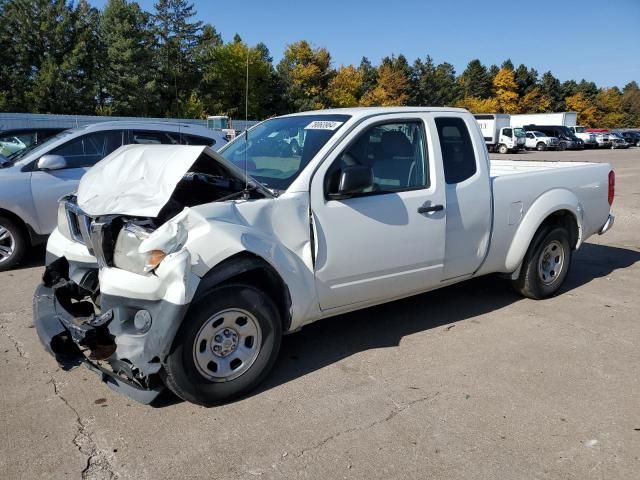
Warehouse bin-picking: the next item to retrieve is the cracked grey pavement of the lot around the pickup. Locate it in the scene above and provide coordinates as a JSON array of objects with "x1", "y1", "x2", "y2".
[{"x1": 0, "y1": 149, "x2": 640, "y2": 480}]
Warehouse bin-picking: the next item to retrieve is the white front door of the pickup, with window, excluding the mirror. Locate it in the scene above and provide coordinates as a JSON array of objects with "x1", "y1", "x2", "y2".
[{"x1": 311, "y1": 113, "x2": 446, "y2": 310}]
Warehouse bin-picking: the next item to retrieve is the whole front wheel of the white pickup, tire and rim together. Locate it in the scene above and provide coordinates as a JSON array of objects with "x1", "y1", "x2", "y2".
[{"x1": 163, "y1": 284, "x2": 282, "y2": 406}]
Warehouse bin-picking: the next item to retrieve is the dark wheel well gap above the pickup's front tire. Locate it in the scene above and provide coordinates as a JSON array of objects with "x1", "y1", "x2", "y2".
[{"x1": 194, "y1": 252, "x2": 291, "y2": 332}]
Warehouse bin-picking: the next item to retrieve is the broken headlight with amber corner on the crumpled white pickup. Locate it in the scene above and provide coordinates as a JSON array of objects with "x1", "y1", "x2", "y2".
[{"x1": 113, "y1": 223, "x2": 170, "y2": 275}]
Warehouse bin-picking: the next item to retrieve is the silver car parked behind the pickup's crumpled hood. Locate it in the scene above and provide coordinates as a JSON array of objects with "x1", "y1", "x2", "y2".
[{"x1": 0, "y1": 121, "x2": 226, "y2": 271}]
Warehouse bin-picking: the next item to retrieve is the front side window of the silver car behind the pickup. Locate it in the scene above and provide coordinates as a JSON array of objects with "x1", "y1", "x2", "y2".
[{"x1": 51, "y1": 130, "x2": 124, "y2": 168}]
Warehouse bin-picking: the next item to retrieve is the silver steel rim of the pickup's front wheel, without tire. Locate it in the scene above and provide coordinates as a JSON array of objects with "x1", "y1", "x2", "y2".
[{"x1": 193, "y1": 308, "x2": 262, "y2": 382}]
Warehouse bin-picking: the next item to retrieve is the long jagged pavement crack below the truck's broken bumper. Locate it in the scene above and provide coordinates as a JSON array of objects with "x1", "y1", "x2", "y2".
[{"x1": 48, "y1": 378, "x2": 120, "y2": 480}]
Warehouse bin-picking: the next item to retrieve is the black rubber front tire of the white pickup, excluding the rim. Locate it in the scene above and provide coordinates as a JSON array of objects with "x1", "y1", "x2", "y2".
[{"x1": 162, "y1": 284, "x2": 282, "y2": 406}]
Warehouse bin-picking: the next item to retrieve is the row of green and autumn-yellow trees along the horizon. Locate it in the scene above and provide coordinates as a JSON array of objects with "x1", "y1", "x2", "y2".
[{"x1": 0, "y1": 0, "x2": 640, "y2": 128}]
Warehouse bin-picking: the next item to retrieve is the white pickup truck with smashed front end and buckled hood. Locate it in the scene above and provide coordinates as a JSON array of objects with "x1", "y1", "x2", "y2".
[{"x1": 34, "y1": 107, "x2": 614, "y2": 405}]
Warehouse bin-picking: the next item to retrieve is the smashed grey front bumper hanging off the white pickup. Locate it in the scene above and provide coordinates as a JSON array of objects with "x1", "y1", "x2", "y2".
[{"x1": 33, "y1": 257, "x2": 188, "y2": 404}]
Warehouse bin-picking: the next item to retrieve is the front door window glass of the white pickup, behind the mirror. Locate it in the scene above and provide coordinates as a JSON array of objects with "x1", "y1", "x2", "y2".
[{"x1": 326, "y1": 121, "x2": 429, "y2": 193}]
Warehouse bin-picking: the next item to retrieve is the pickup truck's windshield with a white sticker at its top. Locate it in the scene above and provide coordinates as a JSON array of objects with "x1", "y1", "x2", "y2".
[{"x1": 219, "y1": 115, "x2": 350, "y2": 190}]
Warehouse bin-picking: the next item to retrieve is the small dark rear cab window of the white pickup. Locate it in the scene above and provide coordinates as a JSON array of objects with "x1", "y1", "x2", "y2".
[{"x1": 435, "y1": 117, "x2": 477, "y2": 184}]
